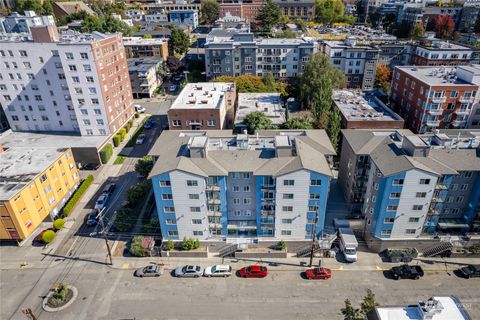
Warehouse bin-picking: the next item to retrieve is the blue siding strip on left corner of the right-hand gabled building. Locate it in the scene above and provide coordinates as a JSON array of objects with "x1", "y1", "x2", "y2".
[{"x1": 371, "y1": 172, "x2": 405, "y2": 238}]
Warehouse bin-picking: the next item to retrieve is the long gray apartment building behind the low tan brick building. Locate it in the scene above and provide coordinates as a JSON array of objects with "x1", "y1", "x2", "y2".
[{"x1": 205, "y1": 32, "x2": 316, "y2": 79}]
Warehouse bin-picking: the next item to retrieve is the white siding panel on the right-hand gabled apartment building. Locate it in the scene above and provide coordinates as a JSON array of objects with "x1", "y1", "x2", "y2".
[{"x1": 391, "y1": 169, "x2": 437, "y2": 238}]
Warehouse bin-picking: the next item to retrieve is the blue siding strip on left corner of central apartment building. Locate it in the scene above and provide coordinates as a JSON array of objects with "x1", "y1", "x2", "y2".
[{"x1": 152, "y1": 173, "x2": 179, "y2": 240}]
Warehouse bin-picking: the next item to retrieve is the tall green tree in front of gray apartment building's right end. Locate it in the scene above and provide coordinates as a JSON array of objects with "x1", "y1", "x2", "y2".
[{"x1": 299, "y1": 52, "x2": 344, "y2": 123}]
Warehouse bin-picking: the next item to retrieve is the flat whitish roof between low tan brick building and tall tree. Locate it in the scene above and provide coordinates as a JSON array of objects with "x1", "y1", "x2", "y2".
[{"x1": 235, "y1": 93, "x2": 285, "y2": 124}]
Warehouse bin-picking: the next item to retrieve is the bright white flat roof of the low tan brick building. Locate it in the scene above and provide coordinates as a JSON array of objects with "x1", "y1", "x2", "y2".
[{"x1": 170, "y1": 82, "x2": 235, "y2": 110}]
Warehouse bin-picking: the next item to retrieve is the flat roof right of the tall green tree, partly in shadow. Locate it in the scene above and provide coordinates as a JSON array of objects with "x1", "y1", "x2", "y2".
[{"x1": 333, "y1": 90, "x2": 403, "y2": 121}]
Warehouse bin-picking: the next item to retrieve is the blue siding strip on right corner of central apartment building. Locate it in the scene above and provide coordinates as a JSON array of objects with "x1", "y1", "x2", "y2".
[{"x1": 305, "y1": 172, "x2": 330, "y2": 239}]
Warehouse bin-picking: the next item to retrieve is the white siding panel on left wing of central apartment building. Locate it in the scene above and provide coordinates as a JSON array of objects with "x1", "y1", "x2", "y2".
[{"x1": 170, "y1": 170, "x2": 209, "y2": 239}]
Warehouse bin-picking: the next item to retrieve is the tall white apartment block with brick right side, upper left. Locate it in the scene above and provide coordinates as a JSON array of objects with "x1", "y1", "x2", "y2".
[{"x1": 0, "y1": 26, "x2": 134, "y2": 136}]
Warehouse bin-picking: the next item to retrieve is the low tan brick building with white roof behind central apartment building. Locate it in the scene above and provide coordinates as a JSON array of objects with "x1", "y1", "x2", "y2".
[{"x1": 168, "y1": 82, "x2": 236, "y2": 130}]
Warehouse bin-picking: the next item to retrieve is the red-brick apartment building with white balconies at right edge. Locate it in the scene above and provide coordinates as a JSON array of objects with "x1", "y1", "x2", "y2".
[{"x1": 390, "y1": 66, "x2": 480, "y2": 133}]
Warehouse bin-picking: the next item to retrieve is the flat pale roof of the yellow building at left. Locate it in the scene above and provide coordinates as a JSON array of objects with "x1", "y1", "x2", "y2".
[{"x1": 0, "y1": 146, "x2": 68, "y2": 201}]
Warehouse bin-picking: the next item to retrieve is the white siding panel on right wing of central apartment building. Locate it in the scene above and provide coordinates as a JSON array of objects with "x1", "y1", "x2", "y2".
[{"x1": 275, "y1": 170, "x2": 310, "y2": 240}]
